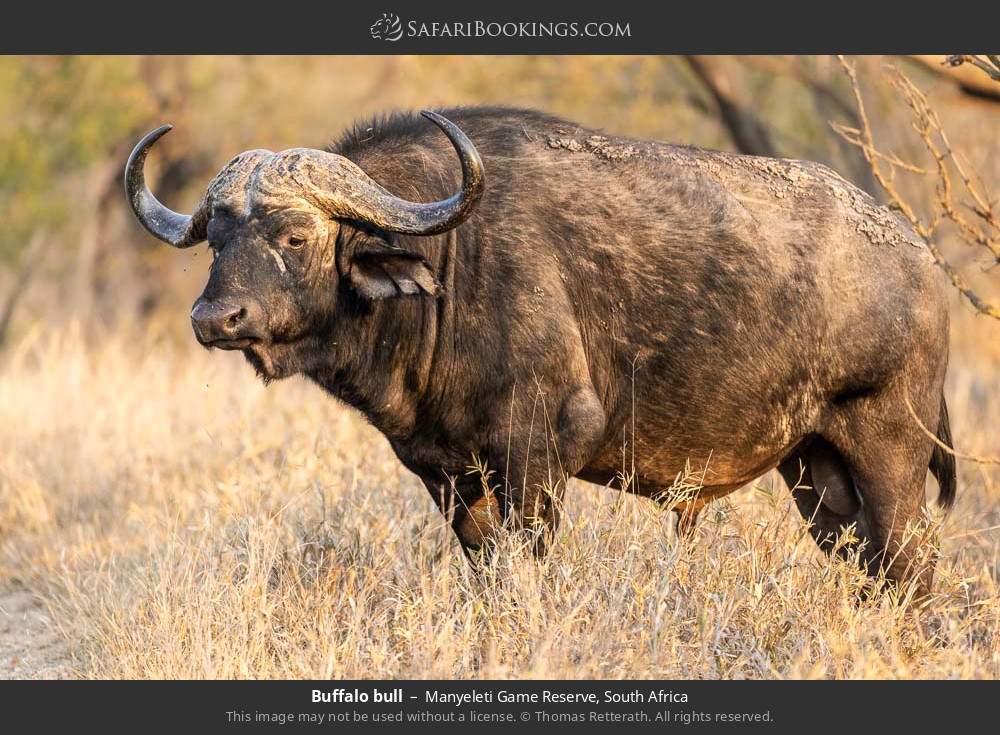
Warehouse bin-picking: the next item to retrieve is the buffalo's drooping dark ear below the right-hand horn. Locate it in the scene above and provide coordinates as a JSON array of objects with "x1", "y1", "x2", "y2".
[{"x1": 342, "y1": 231, "x2": 441, "y2": 299}]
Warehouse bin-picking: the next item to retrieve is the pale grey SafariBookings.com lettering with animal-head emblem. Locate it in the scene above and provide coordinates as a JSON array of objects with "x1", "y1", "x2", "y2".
[{"x1": 368, "y1": 13, "x2": 632, "y2": 41}]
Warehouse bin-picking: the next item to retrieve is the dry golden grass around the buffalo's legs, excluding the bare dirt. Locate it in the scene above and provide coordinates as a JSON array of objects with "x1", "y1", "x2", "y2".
[{"x1": 0, "y1": 313, "x2": 1000, "y2": 678}]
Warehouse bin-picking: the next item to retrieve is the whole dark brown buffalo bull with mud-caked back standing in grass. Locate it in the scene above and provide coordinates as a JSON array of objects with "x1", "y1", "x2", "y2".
[{"x1": 125, "y1": 108, "x2": 955, "y2": 588}]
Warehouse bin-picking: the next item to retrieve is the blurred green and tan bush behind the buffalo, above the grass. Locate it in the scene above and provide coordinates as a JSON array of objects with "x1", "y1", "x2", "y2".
[{"x1": 0, "y1": 56, "x2": 1000, "y2": 341}]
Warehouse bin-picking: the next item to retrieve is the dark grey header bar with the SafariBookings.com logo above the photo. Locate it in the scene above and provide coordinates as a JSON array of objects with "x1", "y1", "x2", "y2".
[{"x1": 0, "y1": 0, "x2": 1000, "y2": 54}]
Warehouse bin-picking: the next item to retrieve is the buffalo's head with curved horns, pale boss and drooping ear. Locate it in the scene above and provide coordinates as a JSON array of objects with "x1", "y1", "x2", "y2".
[{"x1": 125, "y1": 112, "x2": 484, "y2": 386}]
